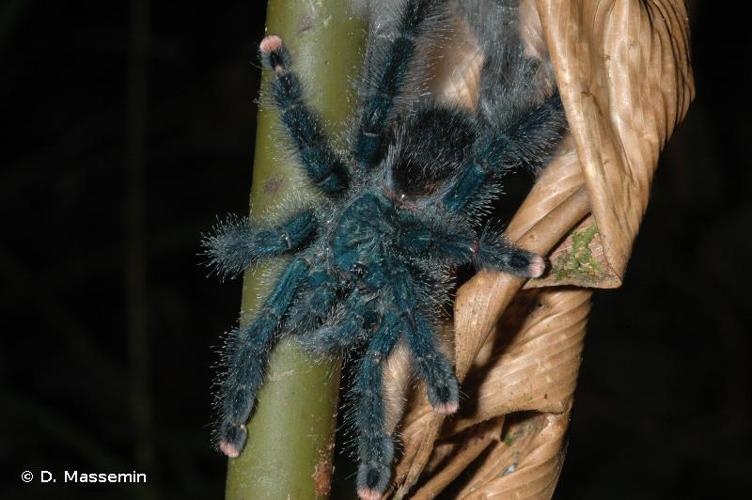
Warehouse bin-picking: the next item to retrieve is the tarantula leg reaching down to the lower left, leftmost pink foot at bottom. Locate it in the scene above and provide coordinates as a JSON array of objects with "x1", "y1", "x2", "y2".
[{"x1": 218, "y1": 257, "x2": 308, "y2": 458}]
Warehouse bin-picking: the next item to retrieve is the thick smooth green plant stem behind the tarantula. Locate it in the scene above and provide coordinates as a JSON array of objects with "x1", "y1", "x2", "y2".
[{"x1": 226, "y1": 0, "x2": 365, "y2": 500}]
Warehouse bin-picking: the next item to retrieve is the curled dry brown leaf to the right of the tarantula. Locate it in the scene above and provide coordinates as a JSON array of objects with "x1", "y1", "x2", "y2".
[{"x1": 390, "y1": 0, "x2": 694, "y2": 499}]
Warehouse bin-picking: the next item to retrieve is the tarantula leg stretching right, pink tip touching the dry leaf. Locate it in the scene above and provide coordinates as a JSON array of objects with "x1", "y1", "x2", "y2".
[{"x1": 398, "y1": 213, "x2": 546, "y2": 278}]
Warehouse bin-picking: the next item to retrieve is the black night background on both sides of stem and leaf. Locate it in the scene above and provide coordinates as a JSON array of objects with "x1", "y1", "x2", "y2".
[{"x1": 0, "y1": 0, "x2": 752, "y2": 499}]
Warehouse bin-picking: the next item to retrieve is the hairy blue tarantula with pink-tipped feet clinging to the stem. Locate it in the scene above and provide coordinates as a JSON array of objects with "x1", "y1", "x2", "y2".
[{"x1": 205, "y1": 0, "x2": 566, "y2": 499}]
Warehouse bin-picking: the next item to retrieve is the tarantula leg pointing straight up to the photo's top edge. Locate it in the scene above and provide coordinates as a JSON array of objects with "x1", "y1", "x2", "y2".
[{"x1": 354, "y1": 0, "x2": 443, "y2": 169}]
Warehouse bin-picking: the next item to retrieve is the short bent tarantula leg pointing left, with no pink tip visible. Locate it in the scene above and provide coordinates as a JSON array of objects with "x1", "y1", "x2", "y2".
[{"x1": 202, "y1": 210, "x2": 318, "y2": 276}]
